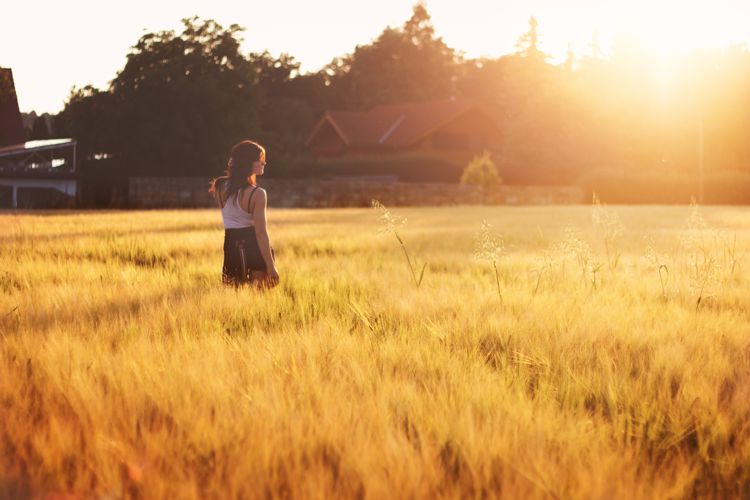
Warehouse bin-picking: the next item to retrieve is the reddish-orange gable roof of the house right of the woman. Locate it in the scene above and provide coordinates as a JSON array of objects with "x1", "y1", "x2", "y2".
[{"x1": 305, "y1": 99, "x2": 494, "y2": 148}]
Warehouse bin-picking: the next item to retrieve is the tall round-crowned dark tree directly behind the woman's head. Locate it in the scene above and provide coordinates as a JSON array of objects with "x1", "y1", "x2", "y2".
[{"x1": 110, "y1": 17, "x2": 264, "y2": 175}]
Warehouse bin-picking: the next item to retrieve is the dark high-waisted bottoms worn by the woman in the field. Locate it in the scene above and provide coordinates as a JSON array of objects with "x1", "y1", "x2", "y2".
[{"x1": 221, "y1": 227, "x2": 273, "y2": 285}]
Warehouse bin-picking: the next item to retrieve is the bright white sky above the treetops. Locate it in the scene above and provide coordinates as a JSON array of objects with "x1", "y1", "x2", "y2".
[{"x1": 0, "y1": 0, "x2": 750, "y2": 112}]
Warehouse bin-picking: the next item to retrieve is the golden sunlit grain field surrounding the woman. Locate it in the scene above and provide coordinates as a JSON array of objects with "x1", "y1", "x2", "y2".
[{"x1": 0, "y1": 206, "x2": 750, "y2": 498}]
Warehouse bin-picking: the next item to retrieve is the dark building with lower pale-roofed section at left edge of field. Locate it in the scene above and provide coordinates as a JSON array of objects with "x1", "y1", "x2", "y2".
[{"x1": 0, "y1": 68, "x2": 78, "y2": 208}]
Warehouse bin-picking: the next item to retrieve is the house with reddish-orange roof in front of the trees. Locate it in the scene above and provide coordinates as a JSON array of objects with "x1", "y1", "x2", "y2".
[{"x1": 305, "y1": 99, "x2": 501, "y2": 165}]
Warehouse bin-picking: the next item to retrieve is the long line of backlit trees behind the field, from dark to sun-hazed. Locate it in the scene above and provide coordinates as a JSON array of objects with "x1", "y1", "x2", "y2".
[{"x1": 45, "y1": 3, "x2": 750, "y2": 182}]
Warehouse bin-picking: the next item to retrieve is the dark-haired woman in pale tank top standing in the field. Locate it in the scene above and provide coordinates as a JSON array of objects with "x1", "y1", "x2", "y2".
[{"x1": 209, "y1": 141, "x2": 279, "y2": 286}]
